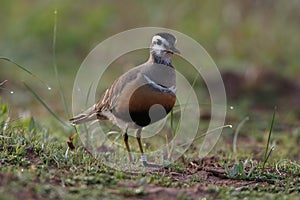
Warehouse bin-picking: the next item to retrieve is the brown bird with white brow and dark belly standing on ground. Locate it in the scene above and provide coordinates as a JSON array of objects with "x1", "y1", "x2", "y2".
[{"x1": 70, "y1": 32, "x2": 180, "y2": 166}]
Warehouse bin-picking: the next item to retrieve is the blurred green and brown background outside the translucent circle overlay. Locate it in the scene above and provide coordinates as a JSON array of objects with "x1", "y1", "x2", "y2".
[{"x1": 0, "y1": 0, "x2": 300, "y2": 119}]
